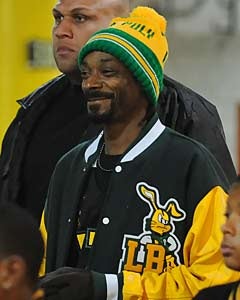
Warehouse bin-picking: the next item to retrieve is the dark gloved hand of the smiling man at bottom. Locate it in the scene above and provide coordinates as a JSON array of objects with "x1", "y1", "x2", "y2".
[{"x1": 39, "y1": 267, "x2": 93, "y2": 300}]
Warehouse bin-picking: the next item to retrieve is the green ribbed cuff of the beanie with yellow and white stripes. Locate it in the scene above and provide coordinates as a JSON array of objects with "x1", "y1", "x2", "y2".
[{"x1": 78, "y1": 28, "x2": 163, "y2": 105}]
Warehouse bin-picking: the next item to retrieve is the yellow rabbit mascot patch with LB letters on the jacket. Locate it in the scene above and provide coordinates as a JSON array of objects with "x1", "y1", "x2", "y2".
[{"x1": 119, "y1": 182, "x2": 186, "y2": 274}]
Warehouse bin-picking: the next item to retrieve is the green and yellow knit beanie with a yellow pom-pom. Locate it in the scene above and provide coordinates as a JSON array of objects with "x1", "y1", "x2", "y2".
[{"x1": 78, "y1": 6, "x2": 168, "y2": 105}]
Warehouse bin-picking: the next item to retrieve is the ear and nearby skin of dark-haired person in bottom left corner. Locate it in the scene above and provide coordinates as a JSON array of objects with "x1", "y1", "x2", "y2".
[{"x1": 0, "y1": 255, "x2": 27, "y2": 290}]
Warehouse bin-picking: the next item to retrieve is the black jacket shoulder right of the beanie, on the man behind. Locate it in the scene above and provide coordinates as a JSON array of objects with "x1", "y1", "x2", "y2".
[{"x1": 157, "y1": 75, "x2": 236, "y2": 183}]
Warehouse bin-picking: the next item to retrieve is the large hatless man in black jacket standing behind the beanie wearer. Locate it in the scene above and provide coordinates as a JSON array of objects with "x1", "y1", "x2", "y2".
[{"x1": 0, "y1": 0, "x2": 236, "y2": 221}]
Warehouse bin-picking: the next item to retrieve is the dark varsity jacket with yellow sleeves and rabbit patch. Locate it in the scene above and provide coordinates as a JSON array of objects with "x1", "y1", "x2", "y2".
[{"x1": 41, "y1": 115, "x2": 239, "y2": 299}]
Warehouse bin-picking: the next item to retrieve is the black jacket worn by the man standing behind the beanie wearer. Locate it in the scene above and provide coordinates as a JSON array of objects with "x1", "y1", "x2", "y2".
[{"x1": 0, "y1": 75, "x2": 236, "y2": 220}]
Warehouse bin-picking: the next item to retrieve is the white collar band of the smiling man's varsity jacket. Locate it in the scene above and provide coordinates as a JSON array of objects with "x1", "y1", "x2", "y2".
[{"x1": 85, "y1": 114, "x2": 165, "y2": 162}]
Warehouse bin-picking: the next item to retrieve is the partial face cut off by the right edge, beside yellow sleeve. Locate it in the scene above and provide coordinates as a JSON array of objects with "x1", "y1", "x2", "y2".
[{"x1": 221, "y1": 187, "x2": 240, "y2": 271}]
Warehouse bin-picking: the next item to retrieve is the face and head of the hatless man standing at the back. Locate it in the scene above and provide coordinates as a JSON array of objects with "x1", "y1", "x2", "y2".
[{"x1": 52, "y1": 0, "x2": 126, "y2": 75}]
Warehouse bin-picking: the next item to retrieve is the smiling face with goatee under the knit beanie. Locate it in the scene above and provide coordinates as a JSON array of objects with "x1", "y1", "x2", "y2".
[{"x1": 80, "y1": 51, "x2": 147, "y2": 124}]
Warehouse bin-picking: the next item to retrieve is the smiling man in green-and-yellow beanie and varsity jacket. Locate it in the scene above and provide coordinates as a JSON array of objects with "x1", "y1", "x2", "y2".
[{"x1": 41, "y1": 7, "x2": 239, "y2": 300}]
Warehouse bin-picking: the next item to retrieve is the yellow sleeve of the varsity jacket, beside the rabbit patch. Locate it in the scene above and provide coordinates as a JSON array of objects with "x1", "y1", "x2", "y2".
[{"x1": 122, "y1": 186, "x2": 240, "y2": 300}]
